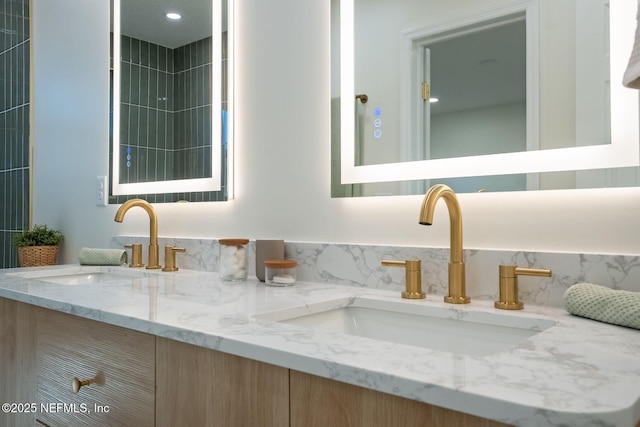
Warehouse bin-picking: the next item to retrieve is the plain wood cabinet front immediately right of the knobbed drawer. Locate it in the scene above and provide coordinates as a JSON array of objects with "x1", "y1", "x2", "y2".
[{"x1": 156, "y1": 337, "x2": 289, "y2": 427}]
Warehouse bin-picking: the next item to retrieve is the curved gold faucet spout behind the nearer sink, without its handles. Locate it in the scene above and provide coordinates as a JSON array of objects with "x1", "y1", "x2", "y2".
[{"x1": 418, "y1": 184, "x2": 471, "y2": 304}]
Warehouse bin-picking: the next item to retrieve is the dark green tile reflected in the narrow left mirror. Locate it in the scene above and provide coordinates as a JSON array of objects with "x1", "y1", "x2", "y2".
[{"x1": 110, "y1": 34, "x2": 227, "y2": 203}]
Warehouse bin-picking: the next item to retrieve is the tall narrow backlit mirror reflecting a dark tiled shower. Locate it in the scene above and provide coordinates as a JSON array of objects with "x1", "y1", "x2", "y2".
[{"x1": 110, "y1": 0, "x2": 233, "y2": 203}]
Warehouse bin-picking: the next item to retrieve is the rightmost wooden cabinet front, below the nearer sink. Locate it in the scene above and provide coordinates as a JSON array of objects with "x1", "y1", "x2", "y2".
[{"x1": 290, "y1": 370, "x2": 506, "y2": 427}]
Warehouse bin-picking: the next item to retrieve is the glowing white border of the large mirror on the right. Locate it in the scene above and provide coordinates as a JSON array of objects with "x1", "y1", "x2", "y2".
[{"x1": 340, "y1": 0, "x2": 640, "y2": 184}]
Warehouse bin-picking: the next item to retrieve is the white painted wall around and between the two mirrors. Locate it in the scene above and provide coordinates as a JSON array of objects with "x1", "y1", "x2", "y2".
[{"x1": 33, "y1": 0, "x2": 640, "y2": 262}]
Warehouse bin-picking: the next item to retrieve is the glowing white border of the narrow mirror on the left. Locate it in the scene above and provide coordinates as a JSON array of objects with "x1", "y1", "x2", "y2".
[{"x1": 111, "y1": 0, "x2": 234, "y2": 200}]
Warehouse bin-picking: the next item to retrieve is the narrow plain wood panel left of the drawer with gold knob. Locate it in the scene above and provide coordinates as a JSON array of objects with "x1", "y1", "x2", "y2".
[{"x1": 0, "y1": 298, "x2": 36, "y2": 427}]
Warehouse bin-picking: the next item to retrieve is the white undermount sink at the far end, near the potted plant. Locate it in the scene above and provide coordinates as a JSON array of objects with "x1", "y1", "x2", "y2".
[{"x1": 11, "y1": 267, "x2": 144, "y2": 286}]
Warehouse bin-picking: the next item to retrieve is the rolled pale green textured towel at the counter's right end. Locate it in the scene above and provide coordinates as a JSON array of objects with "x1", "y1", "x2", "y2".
[{"x1": 564, "y1": 283, "x2": 640, "y2": 329}]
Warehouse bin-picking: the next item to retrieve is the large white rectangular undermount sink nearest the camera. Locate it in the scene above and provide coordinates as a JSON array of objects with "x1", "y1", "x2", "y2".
[{"x1": 254, "y1": 297, "x2": 555, "y2": 356}]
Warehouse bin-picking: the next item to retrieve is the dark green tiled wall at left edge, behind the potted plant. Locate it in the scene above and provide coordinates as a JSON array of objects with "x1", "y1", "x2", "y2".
[{"x1": 0, "y1": 0, "x2": 30, "y2": 268}]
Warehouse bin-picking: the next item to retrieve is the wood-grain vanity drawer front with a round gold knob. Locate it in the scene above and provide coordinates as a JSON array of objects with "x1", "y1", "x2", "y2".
[{"x1": 36, "y1": 309, "x2": 155, "y2": 427}]
